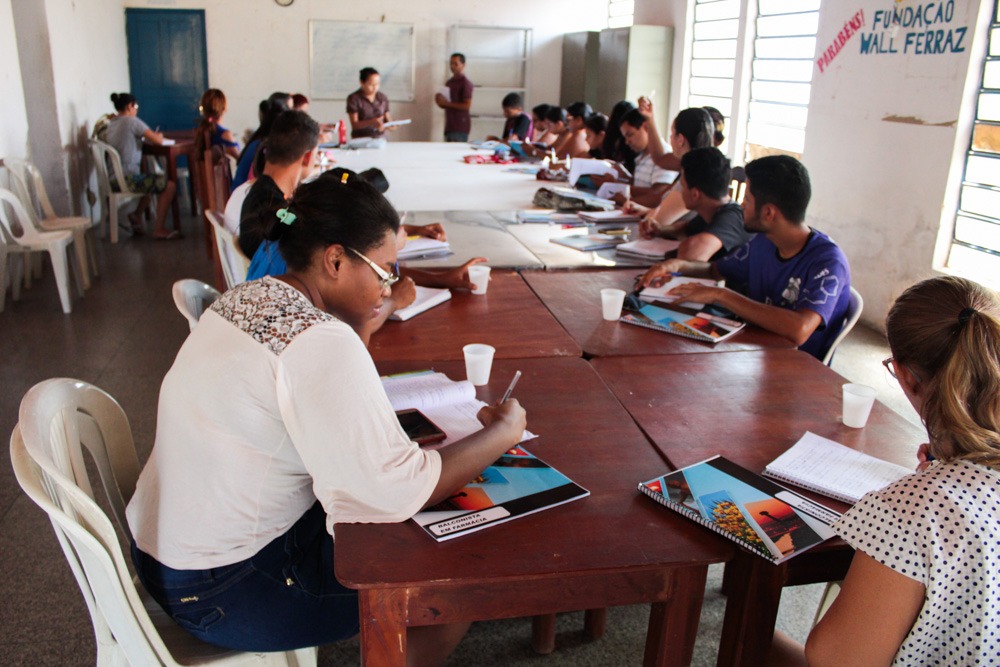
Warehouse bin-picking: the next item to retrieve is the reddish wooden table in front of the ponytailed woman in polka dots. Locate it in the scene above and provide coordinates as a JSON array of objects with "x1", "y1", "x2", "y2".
[{"x1": 590, "y1": 350, "x2": 927, "y2": 665}]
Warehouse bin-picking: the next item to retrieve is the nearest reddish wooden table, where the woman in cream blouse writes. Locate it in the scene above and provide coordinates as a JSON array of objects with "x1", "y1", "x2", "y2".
[{"x1": 335, "y1": 358, "x2": 735, "y2": 667}]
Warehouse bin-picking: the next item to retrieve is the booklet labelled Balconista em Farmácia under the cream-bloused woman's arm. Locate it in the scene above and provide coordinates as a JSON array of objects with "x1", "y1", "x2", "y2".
[{"x1": 413, "y1": 446, "x2": 590, "y2": 542}]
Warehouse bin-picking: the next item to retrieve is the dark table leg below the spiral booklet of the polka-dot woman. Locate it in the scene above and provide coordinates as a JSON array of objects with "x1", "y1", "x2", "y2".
[{"x1": 715, "y1": 551, "x2": 787, "y2": 667}]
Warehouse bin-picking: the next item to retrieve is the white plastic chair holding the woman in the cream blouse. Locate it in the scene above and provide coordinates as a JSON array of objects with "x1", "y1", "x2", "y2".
[{"x1": 10, "y1": 378, "x2": 316, "y2": 667}]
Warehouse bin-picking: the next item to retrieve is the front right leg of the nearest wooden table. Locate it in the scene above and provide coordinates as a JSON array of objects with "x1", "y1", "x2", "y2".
[{"x1": 642, "y1": 566, "x2": 708, "y2": 667}]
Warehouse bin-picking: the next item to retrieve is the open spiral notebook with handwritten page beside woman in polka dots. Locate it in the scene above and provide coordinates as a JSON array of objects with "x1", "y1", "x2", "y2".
[{"x1": 764, "y1": 431, "x2": 913, "y2": 503}]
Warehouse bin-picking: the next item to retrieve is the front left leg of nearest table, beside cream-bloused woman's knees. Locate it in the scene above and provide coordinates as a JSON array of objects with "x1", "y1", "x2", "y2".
[{"x1": 358, "y1": 588, "x2": 407, "y2": 667}]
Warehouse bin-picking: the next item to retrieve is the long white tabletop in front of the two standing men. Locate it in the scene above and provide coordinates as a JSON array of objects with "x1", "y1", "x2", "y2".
[{"x1": 329, "y1": 139, "x2": 543, "y2": 211}]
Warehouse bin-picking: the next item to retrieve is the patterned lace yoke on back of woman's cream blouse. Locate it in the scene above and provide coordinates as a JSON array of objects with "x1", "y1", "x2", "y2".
[{"x1": 212, "y1": 277, "x2": 336, "y2": 355}]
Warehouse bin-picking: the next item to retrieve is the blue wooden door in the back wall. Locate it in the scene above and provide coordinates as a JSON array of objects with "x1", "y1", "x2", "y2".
[{"x1": 125, "y1": 9, "x2": 208, "y2": 130}]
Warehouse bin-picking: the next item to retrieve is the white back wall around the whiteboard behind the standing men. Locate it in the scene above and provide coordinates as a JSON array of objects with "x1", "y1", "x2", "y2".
[{"x1": 124, "y1": 0, "x2": 607, "y2": 141}]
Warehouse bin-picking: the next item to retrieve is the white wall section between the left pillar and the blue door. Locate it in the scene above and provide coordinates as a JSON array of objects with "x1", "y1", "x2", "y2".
[{"x1": 46, "y1": 0, "x2": 129, "y2": 213}]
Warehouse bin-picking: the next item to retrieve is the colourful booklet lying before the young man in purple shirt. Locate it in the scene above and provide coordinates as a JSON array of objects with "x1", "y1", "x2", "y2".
[{"x1": 620, "y1": 297, "x2": 746, "y2": 344}]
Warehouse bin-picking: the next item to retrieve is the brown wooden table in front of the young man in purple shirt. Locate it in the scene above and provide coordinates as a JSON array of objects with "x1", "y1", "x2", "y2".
[{"x1": 522, "y1": 269, "x2": 794, "y2": 357}]
